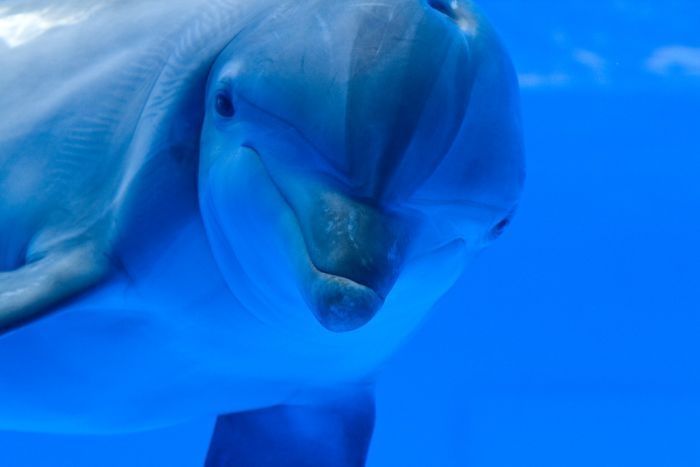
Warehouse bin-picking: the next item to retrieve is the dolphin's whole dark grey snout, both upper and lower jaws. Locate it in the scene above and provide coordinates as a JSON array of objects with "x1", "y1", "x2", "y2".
[{"x1": 303, "y1": 191, "x2": 407, "y2": 332}]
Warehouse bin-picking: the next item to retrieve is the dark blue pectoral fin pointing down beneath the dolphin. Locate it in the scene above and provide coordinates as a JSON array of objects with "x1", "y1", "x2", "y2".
[{"x1": 205, "y1": 388, "x2": 374, "y2": 467}]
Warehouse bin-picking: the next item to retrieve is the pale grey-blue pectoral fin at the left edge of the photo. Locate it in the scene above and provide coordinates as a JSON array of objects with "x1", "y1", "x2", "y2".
[{"x1": 0, "y1": 244, "x2": 107, "y2": 335}]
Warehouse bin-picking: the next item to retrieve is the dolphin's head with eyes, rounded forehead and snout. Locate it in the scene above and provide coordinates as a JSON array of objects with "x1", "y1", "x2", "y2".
[{"x1": 199, "y1": 0, "x2": 523, "y2": 332}]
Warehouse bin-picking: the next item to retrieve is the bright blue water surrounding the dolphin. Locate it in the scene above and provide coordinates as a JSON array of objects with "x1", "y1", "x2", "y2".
[{"x1": 0, "y1": 0, "x2": 700, "y2": 467}]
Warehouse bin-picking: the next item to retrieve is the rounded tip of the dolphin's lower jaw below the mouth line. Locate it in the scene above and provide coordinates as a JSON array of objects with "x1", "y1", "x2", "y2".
[{"x1": 307, "y1": 264, "x2": 384, "y2": 332}]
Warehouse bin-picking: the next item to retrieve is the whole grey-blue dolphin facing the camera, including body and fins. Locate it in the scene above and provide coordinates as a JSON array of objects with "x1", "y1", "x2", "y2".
[{"x1": 0, "y1": 0, "x2": 524, "y2": 466}]
